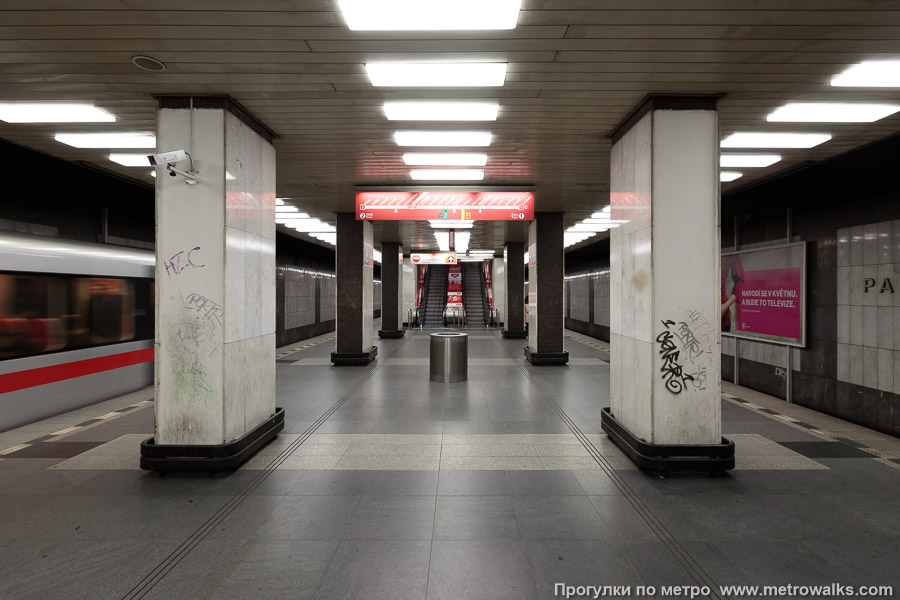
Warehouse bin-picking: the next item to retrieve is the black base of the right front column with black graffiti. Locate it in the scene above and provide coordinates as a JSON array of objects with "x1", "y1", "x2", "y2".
[{"x1": 600, "y1": 406, "x2": 734, "y2": 475}]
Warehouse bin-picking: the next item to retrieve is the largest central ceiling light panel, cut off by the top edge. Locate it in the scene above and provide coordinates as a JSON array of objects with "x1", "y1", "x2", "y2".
[{"x1": 338, "y1": 0, "x2": 522, "y2": 31}]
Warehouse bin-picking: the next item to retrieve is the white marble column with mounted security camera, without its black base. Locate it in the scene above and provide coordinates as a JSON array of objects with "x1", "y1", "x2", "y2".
[{"x1": 155, "y1": 98, "x2": 275, "y2": 445}]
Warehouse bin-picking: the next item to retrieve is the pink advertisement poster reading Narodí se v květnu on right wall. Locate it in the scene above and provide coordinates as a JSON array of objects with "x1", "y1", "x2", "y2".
[{"x1": 721, "y1": 243, "x2": 806, "y2": 346}]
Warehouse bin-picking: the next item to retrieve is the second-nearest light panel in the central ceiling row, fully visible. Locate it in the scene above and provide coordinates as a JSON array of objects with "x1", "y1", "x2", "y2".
[{"x1": 366, "y1": 62, "x2": 506, "y2": 87}]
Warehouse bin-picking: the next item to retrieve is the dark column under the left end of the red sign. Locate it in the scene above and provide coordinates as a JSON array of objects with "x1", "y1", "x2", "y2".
[{"x1": 331, "y1": 213, "x2": 383, "y2": 365}]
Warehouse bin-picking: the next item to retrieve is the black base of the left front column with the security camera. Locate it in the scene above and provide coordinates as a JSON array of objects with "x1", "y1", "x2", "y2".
[{"x1": 141, "y1": 408, "x2": 284, "y2": 473}]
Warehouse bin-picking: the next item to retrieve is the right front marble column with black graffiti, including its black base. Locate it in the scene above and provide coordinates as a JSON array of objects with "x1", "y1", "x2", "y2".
[{"x1": 603, "y1": 96, "x2": 734, "y2": 471}]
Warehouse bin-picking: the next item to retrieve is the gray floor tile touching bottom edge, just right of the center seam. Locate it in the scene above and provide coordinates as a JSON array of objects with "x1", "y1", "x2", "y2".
[{"x1": 428, "y1": 540, "x2": 537, "y2": 600}]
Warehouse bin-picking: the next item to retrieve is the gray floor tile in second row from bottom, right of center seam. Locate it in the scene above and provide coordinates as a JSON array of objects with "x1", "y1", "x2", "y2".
[{"x1": 434, "y1": 496, "x2": 521, "y2": 540}]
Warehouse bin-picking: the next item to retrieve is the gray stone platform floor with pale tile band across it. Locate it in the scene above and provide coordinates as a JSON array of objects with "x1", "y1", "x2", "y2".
[{"x1": 0, "y1": 331, "x2": 900, "y2": 600}]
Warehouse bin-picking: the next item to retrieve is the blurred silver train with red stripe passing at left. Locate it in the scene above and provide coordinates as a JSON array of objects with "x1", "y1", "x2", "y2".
[{"x1": 0, "y1": 232, "x2": 155, "y2": 431}]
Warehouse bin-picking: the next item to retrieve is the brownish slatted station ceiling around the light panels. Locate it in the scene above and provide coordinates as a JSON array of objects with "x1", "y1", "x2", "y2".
[{"x1": 0, "y1": 0, "x2": 900, "y2": 248}]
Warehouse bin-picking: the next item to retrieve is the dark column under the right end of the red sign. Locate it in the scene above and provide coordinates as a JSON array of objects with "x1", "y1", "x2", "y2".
[{"x1": 525, "y1": 213, "x2": 569, "y2": 365}]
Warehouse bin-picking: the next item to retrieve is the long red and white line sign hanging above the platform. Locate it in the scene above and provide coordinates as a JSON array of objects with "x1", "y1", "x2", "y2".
[{"x1": 356, "y1": 192, "x2": 534, "y2": 221}]
